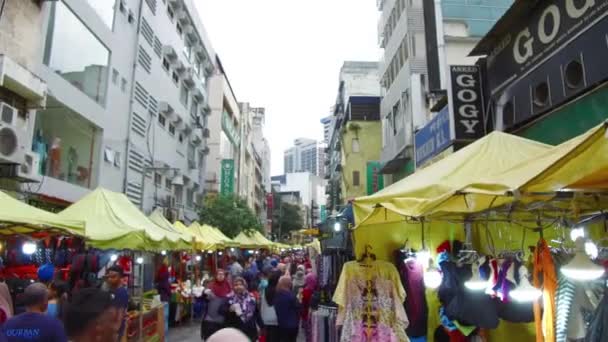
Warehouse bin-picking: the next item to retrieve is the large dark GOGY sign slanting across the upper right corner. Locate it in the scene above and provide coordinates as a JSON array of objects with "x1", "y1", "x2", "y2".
[{"x1": 487, "y1": 0, "x2": 608, "y2": 95}]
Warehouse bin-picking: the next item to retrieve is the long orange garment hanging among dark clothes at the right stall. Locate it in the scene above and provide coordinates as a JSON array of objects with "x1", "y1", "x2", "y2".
[{"x1": 533, "y1": 239, "x2": 557, "y2": 342}]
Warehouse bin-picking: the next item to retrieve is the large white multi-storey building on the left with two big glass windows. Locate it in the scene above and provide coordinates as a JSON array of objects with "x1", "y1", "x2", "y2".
[{"x1": 2, "y1": 0, "x2": 215, "y2": 221}]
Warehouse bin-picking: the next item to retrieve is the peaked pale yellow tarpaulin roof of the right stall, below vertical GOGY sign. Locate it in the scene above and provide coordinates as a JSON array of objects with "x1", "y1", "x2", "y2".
[{"x1": 353, "y1": 132, "x2": 551, "y2": 224}]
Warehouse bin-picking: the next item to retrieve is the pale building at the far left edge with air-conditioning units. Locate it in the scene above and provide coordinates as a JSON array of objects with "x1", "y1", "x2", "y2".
[{"x1": 0, "y1": 0, "x2": 47, "y2": 191}]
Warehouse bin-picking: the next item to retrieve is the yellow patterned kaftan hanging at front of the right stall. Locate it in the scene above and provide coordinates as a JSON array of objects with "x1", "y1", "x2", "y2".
[{"x1": 333, "y1": 261, "x2": 409, "y2": 342}]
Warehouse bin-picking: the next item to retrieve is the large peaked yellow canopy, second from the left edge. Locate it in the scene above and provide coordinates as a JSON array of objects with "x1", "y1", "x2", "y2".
[{"x1": 58, "y1": 188, "x2": 179, "y2": 251}]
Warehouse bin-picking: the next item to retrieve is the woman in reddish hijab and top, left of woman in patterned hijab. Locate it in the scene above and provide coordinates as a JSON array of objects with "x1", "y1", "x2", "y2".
[{"x1": 201, "y1": 269, "x2": 232, "y2": 340}]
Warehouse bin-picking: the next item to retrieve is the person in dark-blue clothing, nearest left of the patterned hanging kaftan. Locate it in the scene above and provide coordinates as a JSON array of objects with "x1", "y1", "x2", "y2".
[{"x1": 274, "y1": 276, "x2": 301, "y2": 342}]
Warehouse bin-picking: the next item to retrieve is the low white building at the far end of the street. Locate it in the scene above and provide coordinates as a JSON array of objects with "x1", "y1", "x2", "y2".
[{"x1": 272, "y1": 172, "x2": 326, "y2": 227}]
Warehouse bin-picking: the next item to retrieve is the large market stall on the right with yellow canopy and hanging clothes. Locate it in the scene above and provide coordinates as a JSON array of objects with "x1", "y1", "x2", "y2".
[{"x1": 334, "y1": 125, "x2": 608, "y2": 341}]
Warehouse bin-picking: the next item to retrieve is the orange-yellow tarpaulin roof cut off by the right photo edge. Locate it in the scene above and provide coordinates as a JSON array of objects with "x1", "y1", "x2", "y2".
[{"x1": 464, "y1": 123, "x2": 608, "y2": 196}]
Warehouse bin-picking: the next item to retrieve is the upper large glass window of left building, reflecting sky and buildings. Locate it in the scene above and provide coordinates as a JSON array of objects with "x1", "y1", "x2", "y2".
[{"x1": 44, "y1": 0, "x2": 110, "y2": 106}]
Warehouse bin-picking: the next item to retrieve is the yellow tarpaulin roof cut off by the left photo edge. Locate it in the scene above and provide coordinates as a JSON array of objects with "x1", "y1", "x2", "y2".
[{"x1": 0, "y1": 191, "x2": 85, "y2": 236}]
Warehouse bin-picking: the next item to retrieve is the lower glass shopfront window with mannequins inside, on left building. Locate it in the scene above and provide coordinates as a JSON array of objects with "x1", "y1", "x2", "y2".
[{"x1": 32, "y1": 99, "x2": 100, "y2": 189}]
